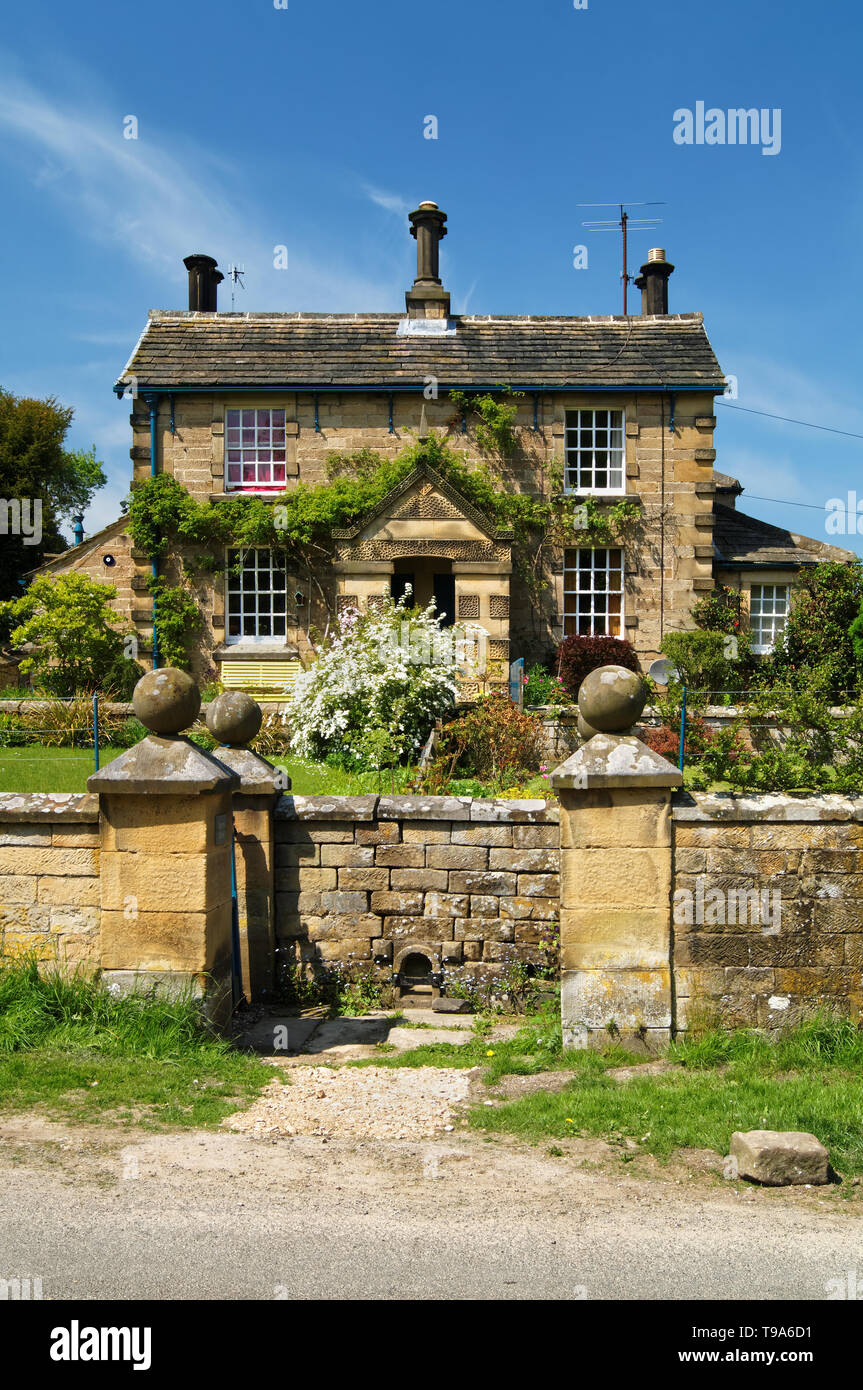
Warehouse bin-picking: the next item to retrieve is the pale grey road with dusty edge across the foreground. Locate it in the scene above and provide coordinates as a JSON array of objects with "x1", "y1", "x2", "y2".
[{"x1": 0, "y1": 1118, "x2": 863, "y2": 1300}]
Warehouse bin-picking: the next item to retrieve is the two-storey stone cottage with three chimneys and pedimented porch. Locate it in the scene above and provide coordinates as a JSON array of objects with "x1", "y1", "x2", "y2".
[{"x1": 35, "y1": 203, "x2": 849, "y2": 694}]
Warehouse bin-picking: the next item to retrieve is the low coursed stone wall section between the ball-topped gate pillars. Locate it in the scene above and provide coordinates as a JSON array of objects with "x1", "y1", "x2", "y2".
[{"x1": 275, "y1": 796, "x2": 560, "y2": 979}]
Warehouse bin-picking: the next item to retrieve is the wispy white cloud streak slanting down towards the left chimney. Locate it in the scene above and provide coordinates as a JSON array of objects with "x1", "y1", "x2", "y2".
[{"x1": 0, "y1": 74, "x2": 407, "y2": 313}]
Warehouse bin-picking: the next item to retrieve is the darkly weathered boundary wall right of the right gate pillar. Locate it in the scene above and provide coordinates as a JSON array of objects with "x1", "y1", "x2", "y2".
[{"x1": 673, "y1": 795, "x2": 863, "y2": 1029}]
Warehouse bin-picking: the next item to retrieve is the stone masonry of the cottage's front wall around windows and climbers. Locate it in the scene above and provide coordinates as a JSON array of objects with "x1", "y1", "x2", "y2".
[{"x1": 120, "y1": 391, "x2": 716, "y2": 677}]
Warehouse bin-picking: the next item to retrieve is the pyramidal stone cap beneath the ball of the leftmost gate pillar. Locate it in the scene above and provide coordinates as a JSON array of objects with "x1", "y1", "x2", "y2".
[{"x1": 88, "y1": 734, "x2": 240, "y2": 796}]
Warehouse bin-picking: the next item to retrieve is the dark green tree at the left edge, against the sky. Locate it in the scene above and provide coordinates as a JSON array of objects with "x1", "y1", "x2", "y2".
[{"x1": 0, "y1": 388, "x2": 106, "y2": 599}]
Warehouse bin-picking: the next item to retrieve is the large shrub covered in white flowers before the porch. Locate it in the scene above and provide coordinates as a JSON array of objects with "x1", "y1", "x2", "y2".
[{"x1": 288, "y1": 594, "x2": 464, "y2": 767}]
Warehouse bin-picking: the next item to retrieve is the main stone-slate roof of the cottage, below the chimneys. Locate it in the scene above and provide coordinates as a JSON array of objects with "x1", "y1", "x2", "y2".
[{"x1": 115, "y1": 310, "x2": 724, "y2": 393}]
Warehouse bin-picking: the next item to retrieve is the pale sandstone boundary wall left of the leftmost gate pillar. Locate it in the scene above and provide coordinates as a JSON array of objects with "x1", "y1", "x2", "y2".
[{"x1": 0, "y1": 792, "x2": 100, "y2": 969}]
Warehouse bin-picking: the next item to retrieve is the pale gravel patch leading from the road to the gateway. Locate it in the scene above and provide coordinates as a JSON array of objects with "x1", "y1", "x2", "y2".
[{"x1": 225, "y1": 1066, "x2": 477, "y2": 1138}]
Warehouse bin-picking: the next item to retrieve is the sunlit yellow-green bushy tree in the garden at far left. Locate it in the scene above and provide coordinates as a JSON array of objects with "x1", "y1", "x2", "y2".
[{"x1": 0, "y1": 574, "x2": 140, "y2": 698}]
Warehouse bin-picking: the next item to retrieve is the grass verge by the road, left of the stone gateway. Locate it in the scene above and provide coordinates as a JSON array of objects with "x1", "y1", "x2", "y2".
[{"x1": 0, "y1": 960, "x2": 272, "y2": 1129}]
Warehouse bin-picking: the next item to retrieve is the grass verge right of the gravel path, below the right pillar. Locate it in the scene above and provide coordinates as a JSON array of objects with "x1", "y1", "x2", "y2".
[{"x1": 353, "y1": 1016, "x2": 863, "y2": 1179}]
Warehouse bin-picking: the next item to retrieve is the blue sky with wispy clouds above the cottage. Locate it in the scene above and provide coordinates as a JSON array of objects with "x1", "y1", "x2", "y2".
[{"x1": 0, "y1": 0, "x2": 863, "y2": 553}]
